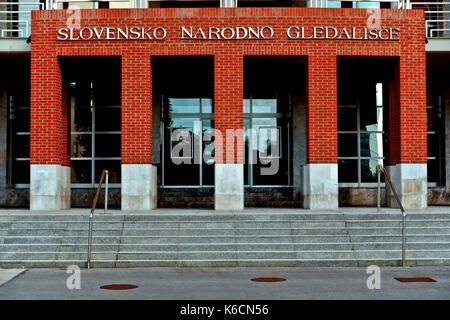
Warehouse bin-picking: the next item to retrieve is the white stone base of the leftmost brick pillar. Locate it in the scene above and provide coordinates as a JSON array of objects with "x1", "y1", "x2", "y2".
[{"x1": 30, "y1": 164, "x2": 71, "y2": 211}]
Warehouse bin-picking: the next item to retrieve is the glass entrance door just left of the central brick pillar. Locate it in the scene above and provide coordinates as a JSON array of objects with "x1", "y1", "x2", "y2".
[{"x1": 161, "y1": 97, "x2": 214, "y2": 187}]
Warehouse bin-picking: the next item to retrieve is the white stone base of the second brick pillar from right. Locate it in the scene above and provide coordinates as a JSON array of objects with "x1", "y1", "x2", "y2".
[{"x1": 300, "y1": 163, "x2": 339, "y2": 209}]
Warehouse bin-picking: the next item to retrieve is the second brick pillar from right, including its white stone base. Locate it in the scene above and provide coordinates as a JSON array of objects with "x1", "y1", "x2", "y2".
[{"x1": 300, "y1": 53, "x2": 338, "y2": 209}]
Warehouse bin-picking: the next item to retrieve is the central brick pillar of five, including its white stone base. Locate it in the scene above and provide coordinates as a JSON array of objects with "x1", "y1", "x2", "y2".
[{"x1": 214, "y1": 52, "x2": 244, "y2": 210}]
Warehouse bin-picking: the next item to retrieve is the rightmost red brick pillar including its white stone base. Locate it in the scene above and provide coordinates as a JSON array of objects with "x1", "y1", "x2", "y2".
[{"x1": 386, "y1": 54, "x2": 427, "y2": 209}]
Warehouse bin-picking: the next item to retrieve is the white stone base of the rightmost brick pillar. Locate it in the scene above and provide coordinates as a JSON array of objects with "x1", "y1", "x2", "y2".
[{"x1": 386, "y1": 163, "x2": 428, "y2": 210}]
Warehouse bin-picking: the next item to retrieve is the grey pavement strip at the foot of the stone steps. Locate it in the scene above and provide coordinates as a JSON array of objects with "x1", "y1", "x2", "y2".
[{"x1": 0, "y1": 267, "x2": 450, "y2": 300}]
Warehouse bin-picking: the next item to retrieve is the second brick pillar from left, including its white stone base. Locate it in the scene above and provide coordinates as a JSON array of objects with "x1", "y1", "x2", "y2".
[{"x1": 121, "y1": 50, "x2": 157, "y2": 210}]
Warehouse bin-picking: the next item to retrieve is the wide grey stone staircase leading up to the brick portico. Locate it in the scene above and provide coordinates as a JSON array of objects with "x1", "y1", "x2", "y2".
[{"x1": 0, "y1": 209, "x2": 450, "y2": 268}]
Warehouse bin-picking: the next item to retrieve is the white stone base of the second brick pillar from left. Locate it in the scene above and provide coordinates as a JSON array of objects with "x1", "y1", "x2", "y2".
[{"x1": 121, "y1": 164, "x2": 158, "y2": 211}]
